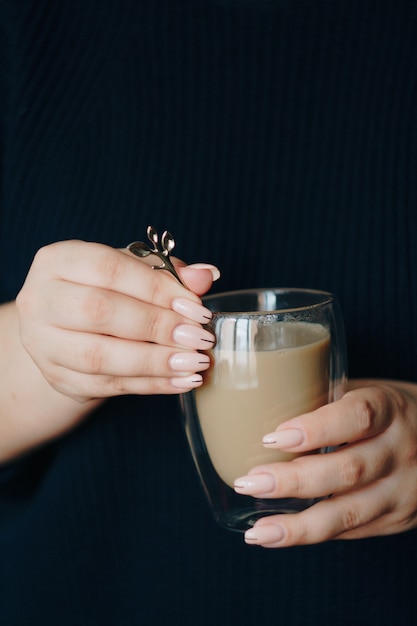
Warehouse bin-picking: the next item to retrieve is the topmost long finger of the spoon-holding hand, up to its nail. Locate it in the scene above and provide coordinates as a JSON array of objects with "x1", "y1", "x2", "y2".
[{"x1": 30, "y1": 241, "x2": 200, "y2": 308}]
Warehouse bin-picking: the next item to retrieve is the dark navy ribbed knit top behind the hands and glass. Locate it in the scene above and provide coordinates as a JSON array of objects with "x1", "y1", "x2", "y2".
[{"x1": 0, "y1": 0, "x2": 417, "y2": 626}]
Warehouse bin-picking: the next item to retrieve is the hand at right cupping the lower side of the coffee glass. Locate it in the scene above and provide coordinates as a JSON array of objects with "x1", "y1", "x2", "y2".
[{"x1": 235, "y1": 381, "x2": 417, "y2": 548}]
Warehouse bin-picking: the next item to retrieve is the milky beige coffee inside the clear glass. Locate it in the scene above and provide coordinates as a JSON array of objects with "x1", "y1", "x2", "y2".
[{"x1": 196, "y1": 322, "x2": 330, "y2": 487}]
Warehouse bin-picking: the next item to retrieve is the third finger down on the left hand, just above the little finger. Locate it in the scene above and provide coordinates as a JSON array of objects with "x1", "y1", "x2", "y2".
[{"x1": 45, "y1": 329, "x2": 210, "y2": 378}]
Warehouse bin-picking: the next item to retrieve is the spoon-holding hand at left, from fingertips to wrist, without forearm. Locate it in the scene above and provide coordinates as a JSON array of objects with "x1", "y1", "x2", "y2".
[{"x1": 16, "y1": 236, "x2": 215, "y2": 402}]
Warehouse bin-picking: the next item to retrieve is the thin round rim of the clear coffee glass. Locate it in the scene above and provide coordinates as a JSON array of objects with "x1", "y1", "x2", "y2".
[{"x1": 202, "y1": 287, "x2": 335, "y2": 316}]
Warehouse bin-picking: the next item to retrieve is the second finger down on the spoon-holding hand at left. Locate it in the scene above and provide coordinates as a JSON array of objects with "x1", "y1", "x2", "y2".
[{"x1": 38, "y1": 281, "x2": 214, "y2": 350}]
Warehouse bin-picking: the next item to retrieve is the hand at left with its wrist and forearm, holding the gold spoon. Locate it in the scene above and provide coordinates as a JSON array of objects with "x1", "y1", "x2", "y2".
[{"x1": 0, "y1": 241, "x2": 218, "y2": 463}]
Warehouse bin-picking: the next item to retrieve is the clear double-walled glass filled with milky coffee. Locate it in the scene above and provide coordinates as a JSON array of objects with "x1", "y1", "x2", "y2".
[{"x1": 180, "y1": 289, "x2": 346, "y2": 531}]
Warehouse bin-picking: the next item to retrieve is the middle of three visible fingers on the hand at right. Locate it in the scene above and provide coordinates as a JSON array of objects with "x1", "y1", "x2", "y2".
[{"x1": 235, "y1": 440, "x2": 395, "y2": 498}]
